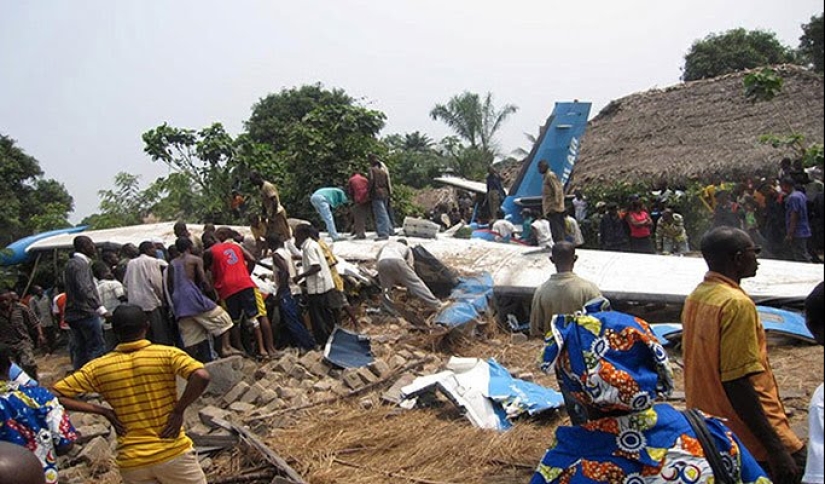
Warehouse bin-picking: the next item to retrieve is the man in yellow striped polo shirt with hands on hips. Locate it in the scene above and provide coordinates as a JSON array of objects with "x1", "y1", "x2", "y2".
[{"x1": 54, "y1": 304, "x2": 210, "y2": 484}]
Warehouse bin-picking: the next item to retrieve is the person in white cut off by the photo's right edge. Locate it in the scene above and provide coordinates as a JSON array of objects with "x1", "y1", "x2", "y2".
[{"x1": 802, "y1": 282, "x2": 825, "y2": 484}]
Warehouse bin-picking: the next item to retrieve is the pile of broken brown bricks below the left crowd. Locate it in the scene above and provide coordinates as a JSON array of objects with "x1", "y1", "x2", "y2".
[{"x1": 55, "y1": 316, "x2": 458, "y2": 484}]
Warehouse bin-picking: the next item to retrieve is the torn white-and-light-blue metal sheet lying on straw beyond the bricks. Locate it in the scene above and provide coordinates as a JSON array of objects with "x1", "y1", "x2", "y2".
[{"x1": 401, "y1": 357, "x2": 564, "y2": 431}]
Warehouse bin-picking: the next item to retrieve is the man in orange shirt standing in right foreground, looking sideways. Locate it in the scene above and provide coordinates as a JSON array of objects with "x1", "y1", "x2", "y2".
[{"x1": 682, "y1": 226, "x2": 805, "y2": 483}]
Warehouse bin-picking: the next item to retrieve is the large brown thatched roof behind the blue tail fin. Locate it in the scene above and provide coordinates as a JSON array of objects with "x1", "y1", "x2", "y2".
[{"x1": 574, "y1": 66, "x2": 823, "y2": 185}]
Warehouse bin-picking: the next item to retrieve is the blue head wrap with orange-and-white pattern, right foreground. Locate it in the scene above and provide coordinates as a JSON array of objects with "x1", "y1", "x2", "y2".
[{"x1": 541, "y1": 311, "x2": 673, "y2": 412}]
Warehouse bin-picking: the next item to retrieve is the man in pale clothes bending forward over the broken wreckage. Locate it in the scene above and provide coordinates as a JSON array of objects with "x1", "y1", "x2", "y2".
[{"x1": 378, "y1": 239, "x2": 442, "y2": 310}]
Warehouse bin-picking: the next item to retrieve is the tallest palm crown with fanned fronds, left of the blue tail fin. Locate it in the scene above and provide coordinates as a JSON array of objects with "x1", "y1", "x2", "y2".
[{"x1": 430, "y1": 91, "x2": 518, "y2": 153}]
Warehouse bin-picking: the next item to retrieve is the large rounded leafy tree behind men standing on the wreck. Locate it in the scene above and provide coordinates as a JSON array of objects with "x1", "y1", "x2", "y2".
[{"x1": 246, "y1": 84, "x2": 386, "y2": 219}]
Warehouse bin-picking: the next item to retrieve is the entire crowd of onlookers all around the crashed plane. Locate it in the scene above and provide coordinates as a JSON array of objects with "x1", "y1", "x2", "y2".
[{"x1": 0, "y1": 152, "x2": 823, "y2": 484}]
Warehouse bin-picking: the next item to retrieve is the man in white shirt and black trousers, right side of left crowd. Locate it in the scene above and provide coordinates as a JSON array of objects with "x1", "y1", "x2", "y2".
[{"x1": 293, "y1": 224, "x2": 339, "y2": 345}]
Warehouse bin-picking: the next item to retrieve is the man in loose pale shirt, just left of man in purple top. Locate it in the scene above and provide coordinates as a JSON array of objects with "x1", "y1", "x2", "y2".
[{"x1": 123, "y1": 241, "x2": 175, "y2": 346}]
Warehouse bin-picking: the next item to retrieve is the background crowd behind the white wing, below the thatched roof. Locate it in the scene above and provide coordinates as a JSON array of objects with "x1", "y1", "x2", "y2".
[{"x1": 458, "y1": 158, "x2": 825, "y2": 262}]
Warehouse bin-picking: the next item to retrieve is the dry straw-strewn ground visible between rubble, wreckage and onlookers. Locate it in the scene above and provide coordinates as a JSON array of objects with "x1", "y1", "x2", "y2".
[{"x1": 39, "y1": 308, "x2": 825, "y2": 484}]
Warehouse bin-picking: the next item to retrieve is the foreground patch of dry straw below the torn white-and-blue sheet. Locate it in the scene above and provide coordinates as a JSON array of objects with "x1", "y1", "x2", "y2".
[{"x1": 268, "y1": 404, "x2": 552, "y2": 484}]
